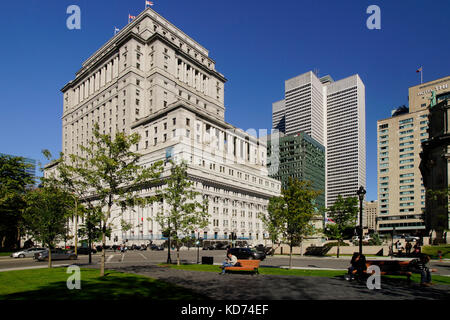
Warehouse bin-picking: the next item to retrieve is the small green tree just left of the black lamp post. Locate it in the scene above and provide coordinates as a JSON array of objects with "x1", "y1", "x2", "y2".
[{"x1": 324, "y1": 195, "x2": 358, "y2": 258}]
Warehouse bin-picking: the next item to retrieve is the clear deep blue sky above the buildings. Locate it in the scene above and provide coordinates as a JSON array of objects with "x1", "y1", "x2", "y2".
[{"x1": 0, "y1": 0, "x2": 450, "y2": 200}]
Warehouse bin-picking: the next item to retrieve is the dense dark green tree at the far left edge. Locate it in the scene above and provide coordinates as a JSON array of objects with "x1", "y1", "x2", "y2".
[{"x1": 0, "y1": 154, "x2": 35, "y2": 248}]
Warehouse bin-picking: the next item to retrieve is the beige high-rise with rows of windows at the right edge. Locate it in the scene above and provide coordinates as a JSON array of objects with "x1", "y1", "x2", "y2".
[{"x1": 377, "y1": 77, "x2": 450, "y2": 234}]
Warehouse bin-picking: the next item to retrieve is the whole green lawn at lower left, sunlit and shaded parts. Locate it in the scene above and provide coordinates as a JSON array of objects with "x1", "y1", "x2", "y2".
[{"x1": 0, "y1": 268, "x2": 206, "y2": 300}]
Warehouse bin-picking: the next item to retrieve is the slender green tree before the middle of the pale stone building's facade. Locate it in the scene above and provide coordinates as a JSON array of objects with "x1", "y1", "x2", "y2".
[{"x1": 156, "y1": 161, "x2": 209, "y2": 265}]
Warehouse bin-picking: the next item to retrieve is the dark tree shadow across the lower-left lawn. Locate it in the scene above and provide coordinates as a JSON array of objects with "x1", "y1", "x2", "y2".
[{"x1": 0, "y1": 274, "x2": 207, "y2": 300}]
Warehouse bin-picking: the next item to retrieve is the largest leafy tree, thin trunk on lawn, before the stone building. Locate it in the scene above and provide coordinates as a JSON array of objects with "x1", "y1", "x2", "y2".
[{"x1": 60, "y1": 124, "x2": 162, "y2": 276}]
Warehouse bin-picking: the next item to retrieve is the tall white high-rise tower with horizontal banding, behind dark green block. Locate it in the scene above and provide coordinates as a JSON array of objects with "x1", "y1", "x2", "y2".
[{"x1": 272, "y1": 71, "x2": 366, "y2": 207}]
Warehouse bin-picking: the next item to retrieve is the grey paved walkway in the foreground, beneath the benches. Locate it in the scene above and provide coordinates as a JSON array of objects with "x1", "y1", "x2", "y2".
[{"x1": 108, "y1": 265, "x2": 450, "y2": 300}]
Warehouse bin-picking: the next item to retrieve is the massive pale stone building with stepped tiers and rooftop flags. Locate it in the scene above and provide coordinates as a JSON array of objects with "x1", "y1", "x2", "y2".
[{"x1": 56, "y1": 8, "x2": 281, "y2": 243}]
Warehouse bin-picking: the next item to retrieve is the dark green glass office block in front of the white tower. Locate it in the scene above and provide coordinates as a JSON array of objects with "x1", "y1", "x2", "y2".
[{"x1": 267, "y1": 132, "x2": 325, "y2": 208}]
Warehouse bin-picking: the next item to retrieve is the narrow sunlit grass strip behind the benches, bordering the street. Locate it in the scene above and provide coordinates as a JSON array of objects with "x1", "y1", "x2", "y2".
[{"x1": 161, "y1": 264, "x2": 450, "y2": 285}]
